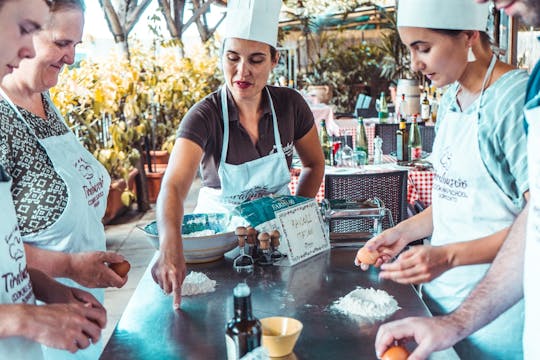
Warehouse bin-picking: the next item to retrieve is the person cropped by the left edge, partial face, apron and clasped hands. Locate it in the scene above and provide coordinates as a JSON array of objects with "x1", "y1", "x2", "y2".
[{"x1": 0, "y1": 0, "x2": 105, "y2": 360}]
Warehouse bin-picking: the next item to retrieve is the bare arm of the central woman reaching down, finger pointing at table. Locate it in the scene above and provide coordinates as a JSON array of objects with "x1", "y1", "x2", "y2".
[{"x1": 152, "y1": 138, "x2": 203, "y2": 308}]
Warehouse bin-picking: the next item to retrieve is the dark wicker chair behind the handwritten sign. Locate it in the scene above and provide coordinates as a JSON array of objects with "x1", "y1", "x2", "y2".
[{"x1": 324, "y1": 171, "x2": 407, "y2": 240}]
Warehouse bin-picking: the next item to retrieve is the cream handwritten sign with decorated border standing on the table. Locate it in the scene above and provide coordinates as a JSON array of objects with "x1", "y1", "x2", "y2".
[{"x1": 275, "y1": 200, "x2": 330, "y2": 266}]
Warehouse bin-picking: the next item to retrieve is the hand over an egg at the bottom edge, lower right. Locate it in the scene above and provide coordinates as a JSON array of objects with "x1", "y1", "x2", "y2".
[{"x1": 375, "y1": 316, "x2": 463, "y2": 360}]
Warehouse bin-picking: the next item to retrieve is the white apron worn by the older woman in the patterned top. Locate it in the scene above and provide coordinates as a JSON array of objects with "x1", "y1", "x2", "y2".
[{"x1": 0, "y1": 89, "x2": 111, "y2": 360}]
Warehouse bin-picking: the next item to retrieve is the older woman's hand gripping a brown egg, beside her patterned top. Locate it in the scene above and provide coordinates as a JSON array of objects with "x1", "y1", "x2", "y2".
[{"x1": 69, "y1": 251, "x2": 127, "y2": 288}]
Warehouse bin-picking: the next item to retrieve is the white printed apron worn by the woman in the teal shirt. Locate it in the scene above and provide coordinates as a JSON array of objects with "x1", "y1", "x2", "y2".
[{"x1": 423, "y1": 54, "x2": 523, "y2": 360}]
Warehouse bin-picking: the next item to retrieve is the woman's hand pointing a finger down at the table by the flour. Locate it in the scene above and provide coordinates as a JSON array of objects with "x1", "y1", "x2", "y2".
[{"x1": 152, "y1": 247, "x2": 187, "y2": 310}]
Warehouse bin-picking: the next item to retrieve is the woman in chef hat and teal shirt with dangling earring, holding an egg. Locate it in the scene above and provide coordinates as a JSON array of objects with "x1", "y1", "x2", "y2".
[{"x1": 356, "y1": 0, "x2": 528, "y2": 359}]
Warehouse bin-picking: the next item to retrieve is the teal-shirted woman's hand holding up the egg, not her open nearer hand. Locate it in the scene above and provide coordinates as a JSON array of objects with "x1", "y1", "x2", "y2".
[{"x1": 354, "y1": 227, "x2": 408, "y2": 270}]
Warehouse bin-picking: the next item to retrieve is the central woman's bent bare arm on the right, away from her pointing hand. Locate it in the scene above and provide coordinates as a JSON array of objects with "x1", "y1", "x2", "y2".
[{"x1": 294, "y1": 125, "x2": 324, "y2": 198}]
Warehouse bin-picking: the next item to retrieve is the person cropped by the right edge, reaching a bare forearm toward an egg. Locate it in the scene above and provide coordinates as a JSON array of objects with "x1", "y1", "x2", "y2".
[{"x1": 375, "y1": 0, "x2": 540, "y2": 360}]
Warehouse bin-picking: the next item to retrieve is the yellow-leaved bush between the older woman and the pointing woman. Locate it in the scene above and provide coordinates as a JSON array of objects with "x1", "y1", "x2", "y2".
[{"x1": 51, "y1": 39, "x2": 221, "y2": 205}]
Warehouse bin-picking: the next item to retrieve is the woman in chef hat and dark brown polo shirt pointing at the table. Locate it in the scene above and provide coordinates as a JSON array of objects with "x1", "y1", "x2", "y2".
[{"x1": 152, "y1": 0, "x2": 324, "y2": 308}]
